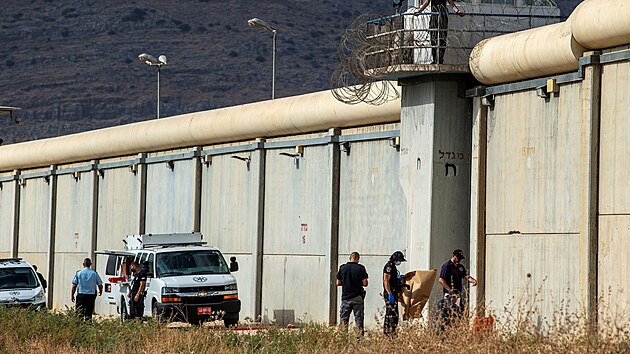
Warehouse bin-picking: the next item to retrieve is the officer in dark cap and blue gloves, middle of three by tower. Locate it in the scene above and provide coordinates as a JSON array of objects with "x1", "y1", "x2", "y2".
[{"x1": 383, "y1": 251, "x2": 406, "y2": 336}]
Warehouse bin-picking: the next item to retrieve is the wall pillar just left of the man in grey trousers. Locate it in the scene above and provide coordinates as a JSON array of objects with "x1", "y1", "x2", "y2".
[{"x1": 328, "y1": 128, "x2": 341, "y2": 325}]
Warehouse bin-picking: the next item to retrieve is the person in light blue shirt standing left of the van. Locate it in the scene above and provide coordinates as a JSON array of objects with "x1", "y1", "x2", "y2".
[{"x1": 72, "y1": 258, "x2": 103, "y2": 320}]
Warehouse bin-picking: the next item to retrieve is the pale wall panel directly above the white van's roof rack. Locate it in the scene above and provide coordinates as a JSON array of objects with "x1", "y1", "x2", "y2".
[{"x1": 146, "y1": 159, "x2": 196, "y2": 233}]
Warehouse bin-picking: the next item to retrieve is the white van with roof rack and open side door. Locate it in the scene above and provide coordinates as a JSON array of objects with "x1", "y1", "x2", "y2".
[{"x1": 96, "y1": 233, "x2": 241, "y2": 327}]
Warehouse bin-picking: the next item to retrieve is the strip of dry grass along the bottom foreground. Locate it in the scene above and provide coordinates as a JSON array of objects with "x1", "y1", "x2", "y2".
[{"x1": 0, "y1": 309, "x2": 630, "y2": 353}]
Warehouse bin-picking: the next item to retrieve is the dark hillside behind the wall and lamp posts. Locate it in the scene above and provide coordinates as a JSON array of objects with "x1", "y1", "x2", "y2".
[{"x1": 0, "y1": 0, "x2": 584, "y2": 144}]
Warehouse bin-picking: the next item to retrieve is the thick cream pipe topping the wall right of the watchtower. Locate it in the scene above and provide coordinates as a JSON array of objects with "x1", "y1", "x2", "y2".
[{"x1": 469, "y1": 0, "x2": 630, "y2": 85}]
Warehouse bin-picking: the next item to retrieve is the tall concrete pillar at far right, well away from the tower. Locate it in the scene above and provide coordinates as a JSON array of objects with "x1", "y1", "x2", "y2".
[{"x1": 578, "y1": 52, "x2": 601, "y2": 331}]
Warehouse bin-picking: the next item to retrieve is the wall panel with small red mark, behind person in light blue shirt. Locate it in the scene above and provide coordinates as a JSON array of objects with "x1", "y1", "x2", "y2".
[{"x1": 52, "y1": 173, "x2": 94, "y2": 310}]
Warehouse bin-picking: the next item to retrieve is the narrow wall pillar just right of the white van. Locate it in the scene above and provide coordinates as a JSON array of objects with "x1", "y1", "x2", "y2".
[{"x1": 252, "y1": 139, "x2": 267, "y2": 320}]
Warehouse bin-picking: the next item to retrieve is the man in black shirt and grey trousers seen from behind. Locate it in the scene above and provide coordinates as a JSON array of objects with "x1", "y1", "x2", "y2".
[{"x1": 337, "y1": 252, "x2": 368, "y2": 335}]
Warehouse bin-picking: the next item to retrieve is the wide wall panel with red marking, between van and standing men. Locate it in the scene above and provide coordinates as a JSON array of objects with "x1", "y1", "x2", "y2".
[{"x1": 262, "y1": 146, "x2": 332, "y2": 322}]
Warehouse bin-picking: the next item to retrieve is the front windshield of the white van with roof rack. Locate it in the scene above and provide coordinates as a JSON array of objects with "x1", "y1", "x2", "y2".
[{"x1": 156, "y1": 250, "x2": 230, "y2": 277}]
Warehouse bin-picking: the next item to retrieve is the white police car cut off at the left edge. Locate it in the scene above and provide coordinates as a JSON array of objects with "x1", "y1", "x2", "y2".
[{"x1": 0, "y1": 258, "x2": 46, "y2": 310}]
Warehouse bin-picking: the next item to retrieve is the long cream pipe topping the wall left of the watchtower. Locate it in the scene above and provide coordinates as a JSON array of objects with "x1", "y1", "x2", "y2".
[{"x1": 0, "y1": 90, "x2": 400, "y2": 171}]
